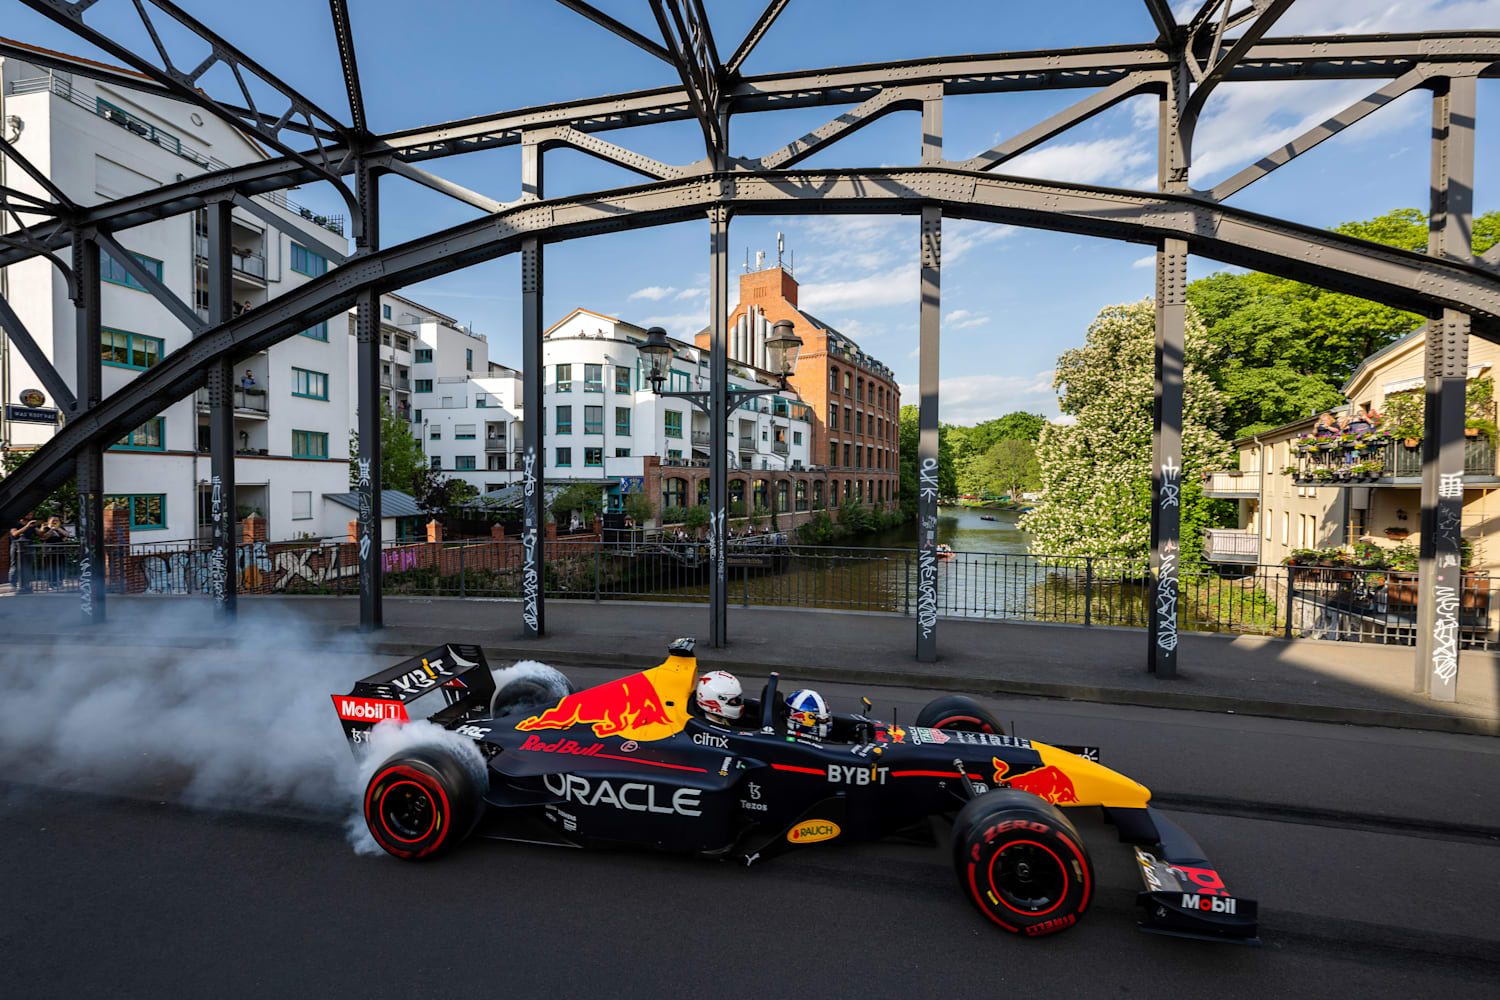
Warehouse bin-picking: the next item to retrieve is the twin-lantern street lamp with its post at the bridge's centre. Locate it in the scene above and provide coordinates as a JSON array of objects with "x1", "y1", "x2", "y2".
[{"x1": 636, "y1": 319, "x2": 803, "y2": 649}]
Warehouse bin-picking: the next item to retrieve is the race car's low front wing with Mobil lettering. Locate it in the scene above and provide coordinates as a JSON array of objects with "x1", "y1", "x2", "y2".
[{"x1": 1106, "y1": 807, "x2": 1260, "y2": 945}]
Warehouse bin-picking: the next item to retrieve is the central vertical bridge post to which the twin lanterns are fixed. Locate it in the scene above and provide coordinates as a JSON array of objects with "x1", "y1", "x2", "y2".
[{"x1": 708, "y1": 205, "x2": 729, "y2": 649}]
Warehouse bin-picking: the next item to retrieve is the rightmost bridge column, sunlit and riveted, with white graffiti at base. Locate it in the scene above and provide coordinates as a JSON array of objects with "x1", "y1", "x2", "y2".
[{"x1": 1413, "y1": 76, "x2": 1476, "y2": 702}]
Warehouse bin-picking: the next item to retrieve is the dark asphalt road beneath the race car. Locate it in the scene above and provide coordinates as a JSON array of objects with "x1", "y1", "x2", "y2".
[{"x1": 0, "y1": 651, "x2": 1500, "y2": 1000}]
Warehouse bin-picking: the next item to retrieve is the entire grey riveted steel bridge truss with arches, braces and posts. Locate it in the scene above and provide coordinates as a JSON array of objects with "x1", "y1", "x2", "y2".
[{"x1": 0, "y1": 0, "x2": 1500, "y2": 700}]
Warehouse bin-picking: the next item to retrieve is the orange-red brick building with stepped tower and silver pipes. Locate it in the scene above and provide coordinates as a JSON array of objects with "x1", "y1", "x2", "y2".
[{"x1": 698, "y1": 264, "x2": 902, "y2": 510}]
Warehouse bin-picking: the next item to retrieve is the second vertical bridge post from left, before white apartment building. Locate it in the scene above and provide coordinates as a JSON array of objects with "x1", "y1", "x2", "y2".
[{"x1": 204, "y1": 199, "x2": 239, "y2": 621}]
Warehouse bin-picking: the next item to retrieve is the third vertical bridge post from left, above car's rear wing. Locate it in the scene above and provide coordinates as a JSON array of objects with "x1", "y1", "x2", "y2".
[{"x1": 354, "y1": 160, "x2": 386, "y2": 631}]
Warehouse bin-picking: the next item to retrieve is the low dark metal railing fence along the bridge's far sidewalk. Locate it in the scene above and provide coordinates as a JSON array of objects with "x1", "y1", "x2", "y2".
[{"x1": 12, "y1": 531, "x2": 1500, "y2": 649}]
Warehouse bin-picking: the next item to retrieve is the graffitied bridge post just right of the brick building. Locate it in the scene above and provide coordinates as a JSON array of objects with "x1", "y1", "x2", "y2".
[{"x1": 917, "y1": 207, "x2": 942, "y2": 663}]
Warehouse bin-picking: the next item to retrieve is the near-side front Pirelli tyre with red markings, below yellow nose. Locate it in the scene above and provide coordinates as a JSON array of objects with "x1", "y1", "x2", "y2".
[{"x1": 953, "y1": 789, "x2": 1094, "y2": 937}]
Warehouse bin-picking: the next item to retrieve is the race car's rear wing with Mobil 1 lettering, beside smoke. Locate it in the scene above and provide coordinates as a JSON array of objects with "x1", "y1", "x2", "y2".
[{"x1": 332, "y1": 642, "x2": 495, "y2": 747}]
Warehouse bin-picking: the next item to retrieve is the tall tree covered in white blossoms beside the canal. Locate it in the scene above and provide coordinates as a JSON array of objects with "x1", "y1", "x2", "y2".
[{"x1": 1022, "y1": 298, "x2": 1233, "y2": 562}]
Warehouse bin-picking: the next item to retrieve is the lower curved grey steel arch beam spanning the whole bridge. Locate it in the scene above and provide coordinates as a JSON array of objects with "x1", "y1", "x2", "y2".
[{"x1": 0, "y1": 166, "x2": 1500, "y2": 517}]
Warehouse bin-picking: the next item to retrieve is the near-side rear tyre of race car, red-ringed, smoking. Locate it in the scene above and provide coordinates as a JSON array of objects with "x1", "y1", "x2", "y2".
[{"x1": 365, "y1": 747, "x2": 483, "y2": 861}]
